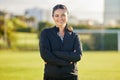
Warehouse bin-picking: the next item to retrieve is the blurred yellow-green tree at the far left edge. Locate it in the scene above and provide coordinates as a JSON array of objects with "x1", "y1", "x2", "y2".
[{"x1": 0, "y1": 16, "x2": 15, "y2": 48}]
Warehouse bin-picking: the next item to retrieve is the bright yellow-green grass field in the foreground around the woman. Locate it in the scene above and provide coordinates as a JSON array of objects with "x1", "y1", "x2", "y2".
[{"x1": 0, "y1": 50, "x2": 120, "y2": 80}]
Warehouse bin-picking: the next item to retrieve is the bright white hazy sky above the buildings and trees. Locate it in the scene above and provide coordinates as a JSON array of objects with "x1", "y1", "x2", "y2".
[{"x1": 0, "y1": 0, "x2": 104, "y2": 22}]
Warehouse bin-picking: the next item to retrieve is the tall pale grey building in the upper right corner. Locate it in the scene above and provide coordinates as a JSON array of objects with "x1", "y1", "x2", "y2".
[{"x1": 104, "y1": 0, "x2": 120, "y2": 26}]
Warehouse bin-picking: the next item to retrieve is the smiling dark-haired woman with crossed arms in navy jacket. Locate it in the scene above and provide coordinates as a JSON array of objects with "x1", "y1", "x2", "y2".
[{"x1": 40, "y1": 4, "x2": 82, "y2": 80}]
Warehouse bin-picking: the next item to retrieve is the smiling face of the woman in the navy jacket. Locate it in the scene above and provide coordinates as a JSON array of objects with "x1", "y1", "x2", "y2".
[{"x1": 53, "y1": 9, "x2": 68, "y2": 27}]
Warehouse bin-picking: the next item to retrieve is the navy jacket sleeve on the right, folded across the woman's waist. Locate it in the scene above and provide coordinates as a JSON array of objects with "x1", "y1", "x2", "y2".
[{"x1": 54, "y1": 35, "x2": 82, "y2": 62}]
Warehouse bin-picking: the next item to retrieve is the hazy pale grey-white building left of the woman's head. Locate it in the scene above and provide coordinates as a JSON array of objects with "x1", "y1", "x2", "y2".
[{"x1": 25, "y1": 8, "x2": 51, "y2": 28}]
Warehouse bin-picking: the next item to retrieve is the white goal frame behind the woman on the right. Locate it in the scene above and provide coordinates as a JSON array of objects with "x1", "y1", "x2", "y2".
[{"x1": 74, "y1": 29, "x2": 120, "y2": 51}]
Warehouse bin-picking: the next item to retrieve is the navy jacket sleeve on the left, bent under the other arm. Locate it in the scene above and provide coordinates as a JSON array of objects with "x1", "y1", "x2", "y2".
[{"x1": 39, "y1": 30, "x2": 69, "y2": 66}]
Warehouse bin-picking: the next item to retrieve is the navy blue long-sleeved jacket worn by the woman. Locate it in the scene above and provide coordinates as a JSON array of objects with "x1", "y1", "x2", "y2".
[{"x1": 39, "y1": 26, "x2": 82, "y2": 78}]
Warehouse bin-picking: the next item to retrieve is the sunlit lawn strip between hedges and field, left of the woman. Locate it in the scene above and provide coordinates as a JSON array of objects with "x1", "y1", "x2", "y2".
[{"x1": 0, "y1": 32, "x2": 39, "y2": 50}]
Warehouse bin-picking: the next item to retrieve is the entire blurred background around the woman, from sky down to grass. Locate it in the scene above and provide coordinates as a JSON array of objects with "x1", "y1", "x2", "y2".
[{"x1": 0, "y1": 0, "x2": 120, "y2": 80}]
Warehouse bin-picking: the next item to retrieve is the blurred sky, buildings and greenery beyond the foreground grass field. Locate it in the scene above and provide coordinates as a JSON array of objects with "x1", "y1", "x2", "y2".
[{"x1": 0, "y1": 0, "x2": 120, "y2": 50}]
